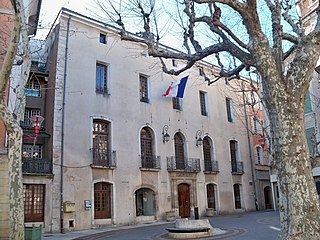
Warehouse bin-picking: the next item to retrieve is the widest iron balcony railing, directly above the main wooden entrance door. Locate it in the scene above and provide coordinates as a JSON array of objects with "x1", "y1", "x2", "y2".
[{"x1": 167, "y1": 156, "x2": 200, "y2": 172}]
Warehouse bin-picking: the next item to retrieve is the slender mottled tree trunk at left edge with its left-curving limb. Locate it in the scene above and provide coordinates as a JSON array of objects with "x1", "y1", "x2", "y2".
[{"x1": 0, "y1": 0, "x2": 26, "y2": 240}]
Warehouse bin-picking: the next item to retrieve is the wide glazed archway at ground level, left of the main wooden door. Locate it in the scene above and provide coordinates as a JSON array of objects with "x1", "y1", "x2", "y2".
[{"x1": 135, "y1": 188, "x2": 155, "y2": 216}]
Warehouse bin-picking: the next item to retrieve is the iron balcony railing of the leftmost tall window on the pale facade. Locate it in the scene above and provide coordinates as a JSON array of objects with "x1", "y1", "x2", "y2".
[{"x1": 90, "y1": 148, "x2": 117, "y2": 168}]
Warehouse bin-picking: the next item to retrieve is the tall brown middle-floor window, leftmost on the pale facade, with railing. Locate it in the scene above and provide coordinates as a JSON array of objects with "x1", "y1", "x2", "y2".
[{"x1": 92, "y1": 120, "x2": 111, "y2": 166}]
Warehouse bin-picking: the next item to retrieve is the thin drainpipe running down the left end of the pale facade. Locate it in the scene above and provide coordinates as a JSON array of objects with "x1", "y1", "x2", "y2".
[{"x1": 60, "y1": 16, "x2": 71, "y2": 233}]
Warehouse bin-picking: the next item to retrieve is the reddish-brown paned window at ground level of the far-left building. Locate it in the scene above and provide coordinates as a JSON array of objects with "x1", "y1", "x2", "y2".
[{"x1": 23, "y1": 184, "x2": 45, "y2": 222}]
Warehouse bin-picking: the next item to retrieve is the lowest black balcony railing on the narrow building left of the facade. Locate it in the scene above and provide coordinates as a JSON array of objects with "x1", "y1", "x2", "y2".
[{"x1": 22, "y1": 158, "x2": 52, "y2": 174}]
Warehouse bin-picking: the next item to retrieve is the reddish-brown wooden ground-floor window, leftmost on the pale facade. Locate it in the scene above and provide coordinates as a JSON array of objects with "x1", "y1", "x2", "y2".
[{"x1": 94, "y1": 182, "x2": 112, "y2": 219}]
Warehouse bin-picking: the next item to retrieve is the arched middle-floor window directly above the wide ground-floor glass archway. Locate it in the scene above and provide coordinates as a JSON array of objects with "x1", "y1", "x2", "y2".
[{"x1": 140, "y1": 127, "x2": 155, "y2": 168}]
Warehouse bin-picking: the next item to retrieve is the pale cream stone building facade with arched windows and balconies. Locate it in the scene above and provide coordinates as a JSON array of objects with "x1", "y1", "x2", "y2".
[{"x1": 36, "y1": 9, "x2": 255, "y2": 232}]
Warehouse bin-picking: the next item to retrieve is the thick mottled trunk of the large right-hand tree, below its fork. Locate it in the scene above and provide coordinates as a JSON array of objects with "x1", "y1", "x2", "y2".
[{"x1": 270, "y1": 103, "x2": 320, "y2": 240}]
